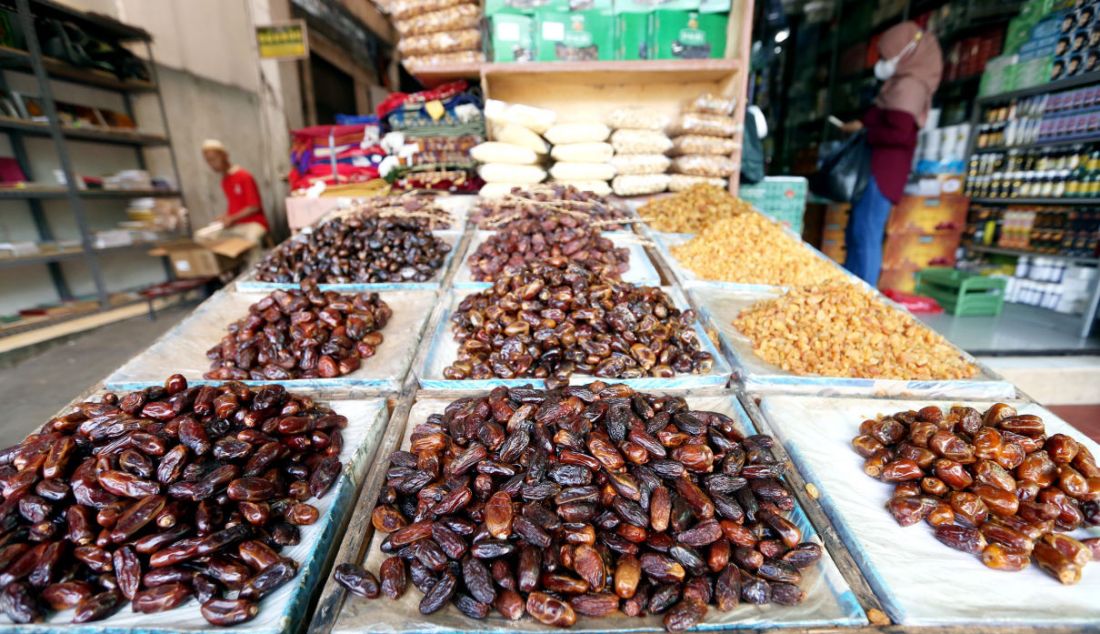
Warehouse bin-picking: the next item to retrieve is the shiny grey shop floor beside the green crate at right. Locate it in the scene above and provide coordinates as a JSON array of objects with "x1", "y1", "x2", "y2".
[{"x1": 917, "y1": 304, "x2": 1100, "y2": 356}]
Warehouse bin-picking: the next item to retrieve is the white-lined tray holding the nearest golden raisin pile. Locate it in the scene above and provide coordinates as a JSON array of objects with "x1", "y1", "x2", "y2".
[{"x1": 689, "y1": 286, "x2": 1016, "y2": 400}]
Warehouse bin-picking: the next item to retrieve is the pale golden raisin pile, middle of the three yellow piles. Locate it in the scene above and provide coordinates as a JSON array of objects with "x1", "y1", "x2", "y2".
[{"x1": 672, "y1": 211, "x2": 843, "y2": 286}]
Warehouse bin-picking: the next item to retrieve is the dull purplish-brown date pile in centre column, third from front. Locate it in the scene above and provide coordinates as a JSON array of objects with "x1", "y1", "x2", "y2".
[{"x1": 470, "y1": 215, "x2": 630, "y2": 282}]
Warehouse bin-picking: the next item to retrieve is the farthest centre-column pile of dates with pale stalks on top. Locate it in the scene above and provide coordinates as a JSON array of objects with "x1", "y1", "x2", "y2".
[{"x1": 470, "y1": 185, "x2": 633, "y2": 231}]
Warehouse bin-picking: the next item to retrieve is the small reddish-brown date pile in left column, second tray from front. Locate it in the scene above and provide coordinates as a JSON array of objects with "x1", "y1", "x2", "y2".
[{"x1": 204, "y1": 280, "x2": 394, "y2": 381}]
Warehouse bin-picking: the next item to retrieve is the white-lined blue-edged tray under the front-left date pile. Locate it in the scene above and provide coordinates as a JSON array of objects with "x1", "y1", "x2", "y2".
[{"x1": 0, "y1": 398, "x2": 387, "y2": 634}]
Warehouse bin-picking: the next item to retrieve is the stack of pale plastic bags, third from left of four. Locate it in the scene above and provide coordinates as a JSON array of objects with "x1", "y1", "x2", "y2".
[{"x1": 607, "y1": 107, "x2": 672, "y2": 196}]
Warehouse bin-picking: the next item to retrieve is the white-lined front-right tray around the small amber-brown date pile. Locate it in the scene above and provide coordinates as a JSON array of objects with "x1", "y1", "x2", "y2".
[{"x1": 760, "y1": 395, "x2": 1100, "y2": 630}]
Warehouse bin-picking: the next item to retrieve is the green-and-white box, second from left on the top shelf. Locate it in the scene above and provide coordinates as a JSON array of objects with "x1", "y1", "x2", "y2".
[{"x1": 535, "y1": 10, "x2": 615, "y2": 62}]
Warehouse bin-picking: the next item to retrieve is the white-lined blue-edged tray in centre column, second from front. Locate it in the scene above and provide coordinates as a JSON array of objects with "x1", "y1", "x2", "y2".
[{"x1": 415, "y1": 286, "x2": 730, "y2": 390}]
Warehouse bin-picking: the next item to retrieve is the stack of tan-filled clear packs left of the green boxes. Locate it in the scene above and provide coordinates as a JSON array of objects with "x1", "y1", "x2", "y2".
[{"x1": 389, "y1": 0, "x2": 485, "y2": 69}]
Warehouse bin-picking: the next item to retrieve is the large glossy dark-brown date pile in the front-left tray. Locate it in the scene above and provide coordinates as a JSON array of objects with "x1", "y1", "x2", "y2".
[{"x1": 0, "y1": 374, "x2": 348, "y2": 625}]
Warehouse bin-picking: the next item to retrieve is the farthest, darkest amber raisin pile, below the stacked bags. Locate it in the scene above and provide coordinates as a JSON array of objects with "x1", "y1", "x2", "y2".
[{"x1": 638, "y1": 185, "x2": 752, "y2": 233}]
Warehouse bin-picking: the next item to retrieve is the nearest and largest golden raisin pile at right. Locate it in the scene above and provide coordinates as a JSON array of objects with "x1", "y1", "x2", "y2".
[{"x1": 734, "y1": 281, "x2": 978, "y2": 380}]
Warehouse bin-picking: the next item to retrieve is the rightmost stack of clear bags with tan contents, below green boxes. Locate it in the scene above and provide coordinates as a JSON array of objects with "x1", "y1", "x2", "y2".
[{"x1": 669, "y1": 94, "x2": 738, "y2": 192}]
